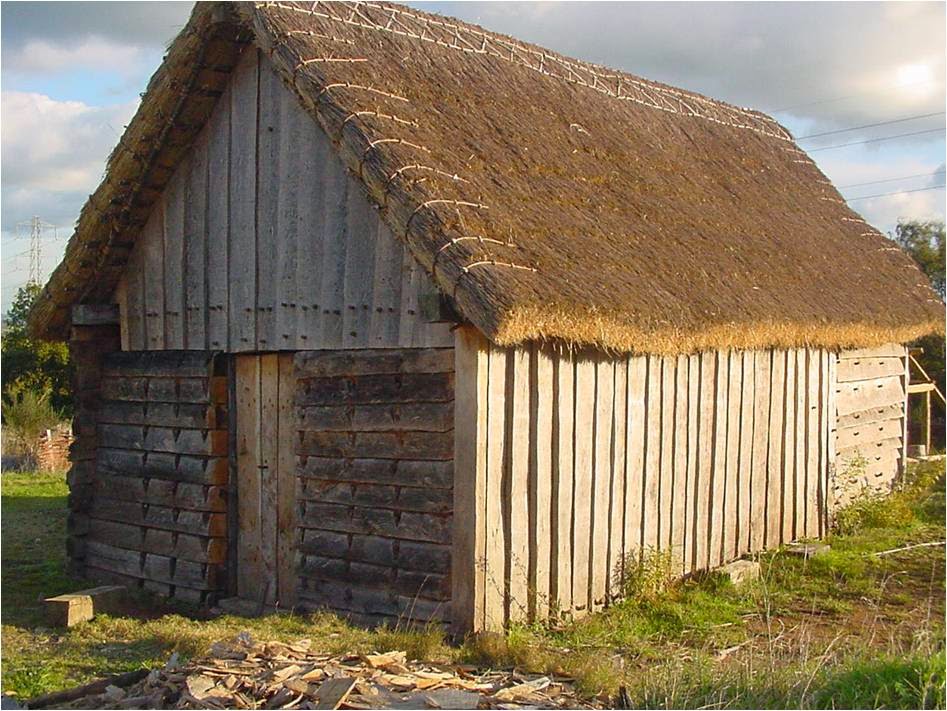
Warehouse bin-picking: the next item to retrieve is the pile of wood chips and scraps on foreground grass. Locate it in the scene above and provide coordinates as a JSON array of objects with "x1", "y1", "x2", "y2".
[{"x1": 30, "y1": 633, "x2": 594, "y2": 709}]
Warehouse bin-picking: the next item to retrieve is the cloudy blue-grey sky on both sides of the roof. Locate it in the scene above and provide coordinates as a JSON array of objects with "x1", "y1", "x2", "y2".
[{"x1": 0, "y1": 2, "x2": 947, "y2": 311}]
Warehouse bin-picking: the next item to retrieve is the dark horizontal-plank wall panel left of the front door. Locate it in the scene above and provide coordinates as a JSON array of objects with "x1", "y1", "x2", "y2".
[{"x1": 76, "y1": 351, "x2": 228, "y2": 603}]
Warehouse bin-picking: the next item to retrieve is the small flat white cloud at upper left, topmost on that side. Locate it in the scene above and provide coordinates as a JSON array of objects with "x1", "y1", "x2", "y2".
[{"x1": 4, "y1": 37, "x2": 145, "y2": 74}]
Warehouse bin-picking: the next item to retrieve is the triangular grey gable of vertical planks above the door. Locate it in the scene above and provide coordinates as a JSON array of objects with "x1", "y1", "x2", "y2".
[{"x1": 115, "y1": 49, "x2": 453, "y2": 353}]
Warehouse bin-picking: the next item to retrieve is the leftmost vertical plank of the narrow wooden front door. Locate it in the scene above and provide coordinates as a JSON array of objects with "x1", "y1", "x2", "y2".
[{"x1": 236, "y1": 355, "x2": 265, "y2": 600}]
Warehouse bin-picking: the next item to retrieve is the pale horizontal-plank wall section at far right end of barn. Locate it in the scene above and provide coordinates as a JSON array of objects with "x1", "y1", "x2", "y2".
[{"x1": 829, "y1": 344, "x2": 908, "y2": 509}]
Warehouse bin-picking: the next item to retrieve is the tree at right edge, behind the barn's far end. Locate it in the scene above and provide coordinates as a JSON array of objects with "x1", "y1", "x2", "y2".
[{"x1": 892, "y1": 220, "x2": 945, "y2": 442}]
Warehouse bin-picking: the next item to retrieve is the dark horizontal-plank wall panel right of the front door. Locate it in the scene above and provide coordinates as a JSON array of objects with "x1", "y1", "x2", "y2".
[{"x1": 295, "y1": 349, "x2": 454, "y2": 624}]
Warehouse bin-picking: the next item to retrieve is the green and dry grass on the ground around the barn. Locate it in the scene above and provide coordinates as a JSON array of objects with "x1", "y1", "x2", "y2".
[{"x1": 0, "y1": 463, "x2": 945, "y2": 708}]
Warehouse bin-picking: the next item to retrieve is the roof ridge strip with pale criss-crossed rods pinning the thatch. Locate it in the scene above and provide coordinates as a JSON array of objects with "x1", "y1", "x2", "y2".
[{"x1": 255, "y1": 0, "x2": 793, "y2": 142}]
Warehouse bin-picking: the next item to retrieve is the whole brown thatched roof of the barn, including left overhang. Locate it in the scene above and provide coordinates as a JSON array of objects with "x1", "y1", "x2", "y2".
[{"x1": 27, "y1": 2, "x2": 943, "y2": 353}]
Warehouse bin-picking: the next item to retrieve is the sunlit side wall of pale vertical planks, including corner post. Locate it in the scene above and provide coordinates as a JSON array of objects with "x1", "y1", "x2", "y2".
[{"x1": 452, "y1": 328, "x2": 834, "y2": 629}]
